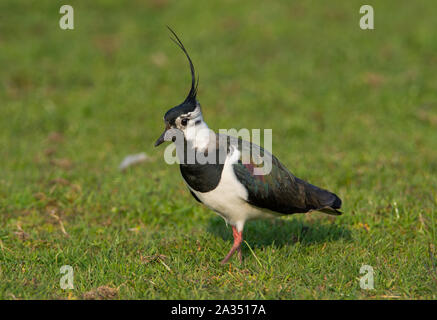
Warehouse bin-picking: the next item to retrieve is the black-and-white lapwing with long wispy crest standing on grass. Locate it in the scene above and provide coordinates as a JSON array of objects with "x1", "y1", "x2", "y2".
[{"x1": 155, "y1": 28, "x2": 341, "y2": 264}]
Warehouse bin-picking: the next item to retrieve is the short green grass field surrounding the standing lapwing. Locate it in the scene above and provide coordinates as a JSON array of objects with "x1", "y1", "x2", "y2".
[{"x1": 0, "y1": 0, "x2": 437, "y2": 299}]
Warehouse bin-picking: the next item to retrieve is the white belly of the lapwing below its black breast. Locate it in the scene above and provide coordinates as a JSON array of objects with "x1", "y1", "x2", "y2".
[{"x1": 187, "y1": 145, "x2": 274, "y2": 231}]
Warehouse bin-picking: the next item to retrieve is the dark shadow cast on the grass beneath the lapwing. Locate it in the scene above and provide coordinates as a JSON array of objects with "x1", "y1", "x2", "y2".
[{"x1": 207, "y1": 217, "x2": 351, "y2": 248}]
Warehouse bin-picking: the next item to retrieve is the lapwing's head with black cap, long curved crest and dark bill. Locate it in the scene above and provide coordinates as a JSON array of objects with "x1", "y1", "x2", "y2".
[{"x1": 155, "y1": 27, "x2": 203, "y2": 147}]
